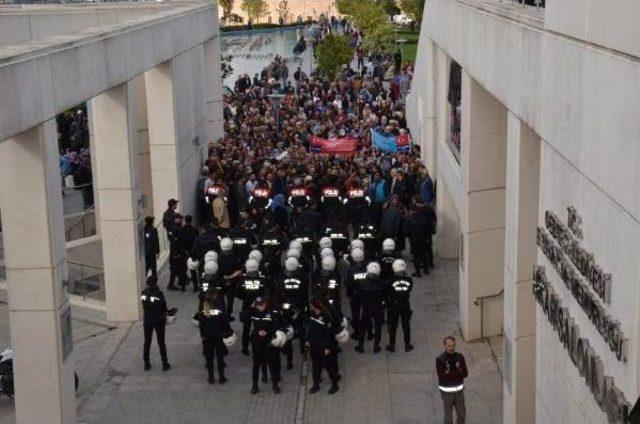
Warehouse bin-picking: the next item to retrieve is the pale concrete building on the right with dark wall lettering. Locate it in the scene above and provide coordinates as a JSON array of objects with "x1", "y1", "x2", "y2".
[{"x1": 408, "y1": 0, "x2": 640, "y2": 424}]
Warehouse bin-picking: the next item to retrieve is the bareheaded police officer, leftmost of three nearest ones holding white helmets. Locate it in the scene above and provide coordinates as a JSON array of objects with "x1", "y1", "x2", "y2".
[{"x1": 193, "y1": 291, "x2": 233, "y2": 384}]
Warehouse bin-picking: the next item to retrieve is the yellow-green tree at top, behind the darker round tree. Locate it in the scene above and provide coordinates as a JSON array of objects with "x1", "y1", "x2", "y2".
[{"x1": 336, "y1": 0, "x2": 394, "y2": 52}]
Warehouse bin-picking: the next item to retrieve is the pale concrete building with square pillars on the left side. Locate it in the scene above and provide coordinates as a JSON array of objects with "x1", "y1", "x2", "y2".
[{"x1": 0, "y1": 1, "x2": 222, "y2": 423}]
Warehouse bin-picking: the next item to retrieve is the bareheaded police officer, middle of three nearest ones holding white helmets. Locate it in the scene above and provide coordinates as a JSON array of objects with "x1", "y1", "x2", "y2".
[{"x1": 249, "y1": 297, "x2": 286, "y2": 395}]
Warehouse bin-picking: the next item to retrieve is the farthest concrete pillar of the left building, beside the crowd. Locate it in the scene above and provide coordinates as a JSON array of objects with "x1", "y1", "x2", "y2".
[{"x1": 202, "y1": 36, "x2": 224, "y2": 142}]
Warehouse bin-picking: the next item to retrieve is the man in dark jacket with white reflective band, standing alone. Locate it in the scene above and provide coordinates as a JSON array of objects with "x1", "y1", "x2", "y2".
[{"x1": 436, "y1": 336, "x2": 469, "y2": 424}]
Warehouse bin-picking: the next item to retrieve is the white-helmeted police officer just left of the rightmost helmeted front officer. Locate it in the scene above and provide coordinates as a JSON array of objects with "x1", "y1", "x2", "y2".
[{"x1": 355, "y1": 262, "x2": 387, "y2": 353}]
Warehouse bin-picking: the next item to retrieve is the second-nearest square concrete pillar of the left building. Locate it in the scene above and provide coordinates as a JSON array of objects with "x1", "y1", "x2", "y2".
[{"x1": 88, "y1": 83, "x2": 144, "y2": 321}]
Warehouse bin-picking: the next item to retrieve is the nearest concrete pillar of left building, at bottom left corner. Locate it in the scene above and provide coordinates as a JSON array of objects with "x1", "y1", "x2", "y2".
[{"x1": 0, "y1": 120, "x2": 76, "y2": 424}]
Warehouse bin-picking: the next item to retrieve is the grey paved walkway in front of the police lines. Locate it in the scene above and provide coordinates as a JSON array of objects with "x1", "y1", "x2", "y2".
[{"x1": 0, "y1": 261, "x2": 502, "y2": 424}]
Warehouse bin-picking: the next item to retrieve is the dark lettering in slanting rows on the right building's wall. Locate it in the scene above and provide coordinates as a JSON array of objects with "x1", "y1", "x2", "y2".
[{"x1": 533, "y1": 207, "x2": 630, "y2": 424}]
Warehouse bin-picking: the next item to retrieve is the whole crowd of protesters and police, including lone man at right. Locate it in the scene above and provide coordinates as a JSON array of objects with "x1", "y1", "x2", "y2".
[{"x1": 142, "y1": 24, "x2": 466, "y2": 422}]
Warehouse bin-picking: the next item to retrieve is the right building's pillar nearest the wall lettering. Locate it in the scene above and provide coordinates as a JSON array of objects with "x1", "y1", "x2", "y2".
[{"x1": 503, "y1": 112, "x2": 541, "y2": 424}]
